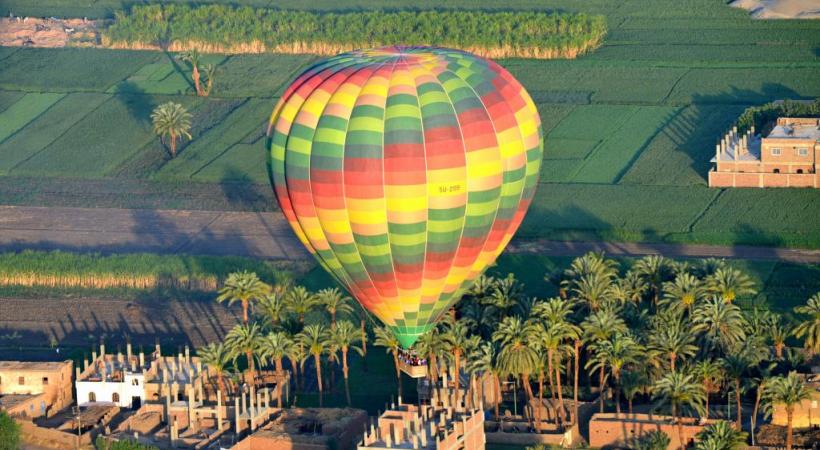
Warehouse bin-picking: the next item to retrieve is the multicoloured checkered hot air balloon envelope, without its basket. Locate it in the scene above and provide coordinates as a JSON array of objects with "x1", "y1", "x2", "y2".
[{"x1": 268, "y1": 47, "x2": 543, "y2": 348}]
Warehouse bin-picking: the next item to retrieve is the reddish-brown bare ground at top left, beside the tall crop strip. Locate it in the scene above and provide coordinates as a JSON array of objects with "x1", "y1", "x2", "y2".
[{"x1": 0, "y1": 17, "x2": 99, "y2": 47}]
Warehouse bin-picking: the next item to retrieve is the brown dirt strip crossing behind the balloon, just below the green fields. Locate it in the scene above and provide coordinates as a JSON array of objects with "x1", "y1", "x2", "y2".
[{"x1": 0, "y1": 206, "x2": 820, "y2": 264}]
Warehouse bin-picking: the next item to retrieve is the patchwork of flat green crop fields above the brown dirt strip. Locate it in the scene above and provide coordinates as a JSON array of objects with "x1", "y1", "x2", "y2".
[{"x1": 0, "y1": 0, "x2": 820, "y2": 248}]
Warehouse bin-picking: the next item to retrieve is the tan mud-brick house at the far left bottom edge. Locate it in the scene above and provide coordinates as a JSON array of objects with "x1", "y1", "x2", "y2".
[{"x1": 0, "y1": 360, "x2": 74, "y2": 418}]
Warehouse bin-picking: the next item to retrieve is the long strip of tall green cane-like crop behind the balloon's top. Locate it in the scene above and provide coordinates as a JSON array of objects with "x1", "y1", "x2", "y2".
[{"x1": 103, "y1": 4, "x2": 606, "y2": 59}]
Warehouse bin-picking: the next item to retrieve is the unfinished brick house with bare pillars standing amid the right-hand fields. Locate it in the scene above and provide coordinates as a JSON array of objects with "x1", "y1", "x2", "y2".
[{"x1": 709, "y1": 117, "x2": 820, "y2": 188}]
